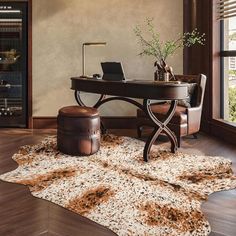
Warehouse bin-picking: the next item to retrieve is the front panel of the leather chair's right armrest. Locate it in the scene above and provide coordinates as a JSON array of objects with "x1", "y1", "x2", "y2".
[{"x1": 187, "y1": 106, "x2": 202, "y2": 134}]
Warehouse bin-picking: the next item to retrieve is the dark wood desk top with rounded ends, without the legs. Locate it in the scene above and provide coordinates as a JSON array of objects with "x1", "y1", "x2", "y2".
[{"x1": 71, "y1": 77, "x2": 188, "y2": 100}]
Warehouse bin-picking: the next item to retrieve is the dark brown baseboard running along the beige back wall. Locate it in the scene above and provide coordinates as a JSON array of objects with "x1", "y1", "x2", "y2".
[{"x1": 33, "y1": 116, "x2": 137, "y2": 129}]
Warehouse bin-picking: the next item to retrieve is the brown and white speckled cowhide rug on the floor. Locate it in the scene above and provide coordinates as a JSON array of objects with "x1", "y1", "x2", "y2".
[{"x1": 0, "y1": 135, "x2": 236, "y2": 236}]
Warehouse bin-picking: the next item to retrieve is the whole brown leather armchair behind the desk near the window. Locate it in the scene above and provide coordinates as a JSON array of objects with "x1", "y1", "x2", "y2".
[{"x1": 137, "y1": 74, "x2": 206, "y2": 147}]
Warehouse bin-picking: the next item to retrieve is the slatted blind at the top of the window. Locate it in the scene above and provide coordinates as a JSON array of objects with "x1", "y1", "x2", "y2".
[{"x1": 219, "y1": 0, "x2": 236, "y2": 20}]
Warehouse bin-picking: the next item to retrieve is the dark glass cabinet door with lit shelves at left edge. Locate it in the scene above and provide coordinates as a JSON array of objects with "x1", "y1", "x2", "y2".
[{"x1": 0, "y1": 2, "x2": 27, "y2": 127}]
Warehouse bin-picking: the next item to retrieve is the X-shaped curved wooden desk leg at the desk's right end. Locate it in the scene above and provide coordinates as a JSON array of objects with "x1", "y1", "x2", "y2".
[{"x1": 143, "y1": 99, "x2": 177, "y2": 162}]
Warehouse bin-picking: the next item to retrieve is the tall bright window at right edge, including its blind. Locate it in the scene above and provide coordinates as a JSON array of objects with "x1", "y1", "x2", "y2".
[{"x1": 219, "y1": 0, "x2": 236, "y2": 124}]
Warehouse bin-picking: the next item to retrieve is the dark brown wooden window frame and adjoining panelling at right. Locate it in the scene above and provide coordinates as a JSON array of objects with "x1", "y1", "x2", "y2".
[{"x1": 183, "y1": 0, "x2": 236, "y2": 145}]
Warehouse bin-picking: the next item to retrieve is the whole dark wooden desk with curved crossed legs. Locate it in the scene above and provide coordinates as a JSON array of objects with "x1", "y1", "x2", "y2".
[{"x1": 71, "y1": 77, "x2": 188, "y2": 161}]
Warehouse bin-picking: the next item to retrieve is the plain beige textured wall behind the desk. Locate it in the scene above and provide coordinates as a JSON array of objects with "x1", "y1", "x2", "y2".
[{"x1": 33, "y1": 0, "x2": 183, "y2": 116}]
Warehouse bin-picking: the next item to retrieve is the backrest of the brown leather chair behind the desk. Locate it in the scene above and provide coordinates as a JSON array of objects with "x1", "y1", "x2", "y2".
[{"x1": 175, "y1": 74, "x2": 206, "y2": 107}]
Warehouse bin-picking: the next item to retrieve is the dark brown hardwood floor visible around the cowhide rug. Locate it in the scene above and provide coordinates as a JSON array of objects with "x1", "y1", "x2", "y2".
[{"x1": 0, "y1": 129, "x2": 236, "y2": 236}]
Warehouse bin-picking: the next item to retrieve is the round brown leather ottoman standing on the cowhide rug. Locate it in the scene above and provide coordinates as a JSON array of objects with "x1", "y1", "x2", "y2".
[{"x1": 57, "y1": 106, "x2": 100, "y2": 156}]
